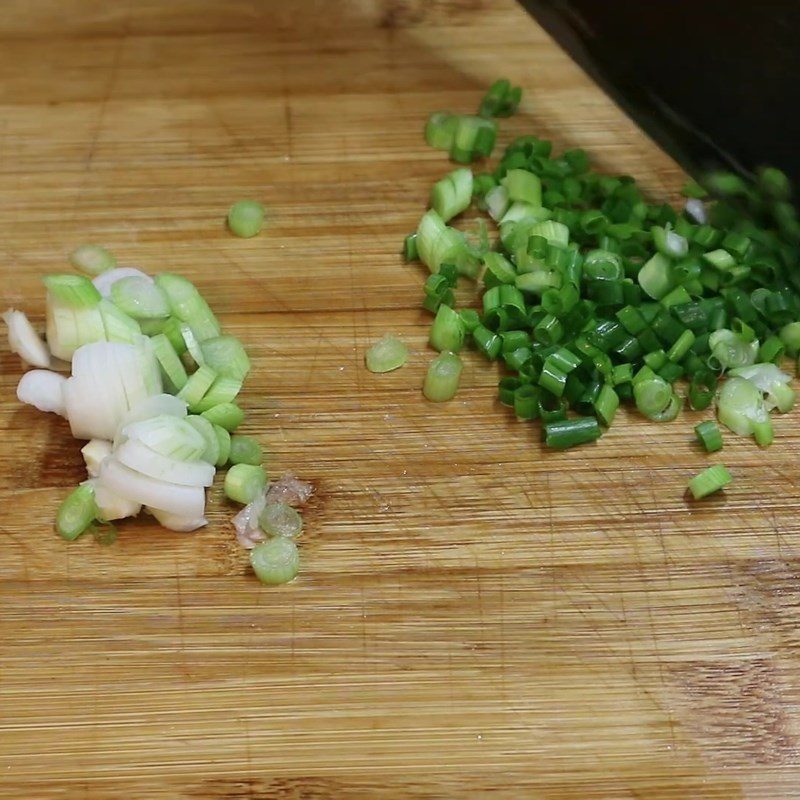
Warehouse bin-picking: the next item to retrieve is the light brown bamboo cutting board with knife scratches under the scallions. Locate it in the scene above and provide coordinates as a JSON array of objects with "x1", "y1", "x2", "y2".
[{"x1": 0, "y1": 0, "x2": 800, "y2": 800}]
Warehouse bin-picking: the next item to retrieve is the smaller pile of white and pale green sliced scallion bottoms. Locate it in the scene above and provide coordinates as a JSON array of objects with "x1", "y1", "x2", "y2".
[{"x1": 4, "y1": 216, "x2": 311, "y2": 585}]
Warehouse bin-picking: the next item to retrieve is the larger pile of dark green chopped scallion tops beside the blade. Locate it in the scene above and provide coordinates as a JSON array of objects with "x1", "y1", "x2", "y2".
[{"x1": 404, "y1": 81, "x2": 800, "y2": 493}]
